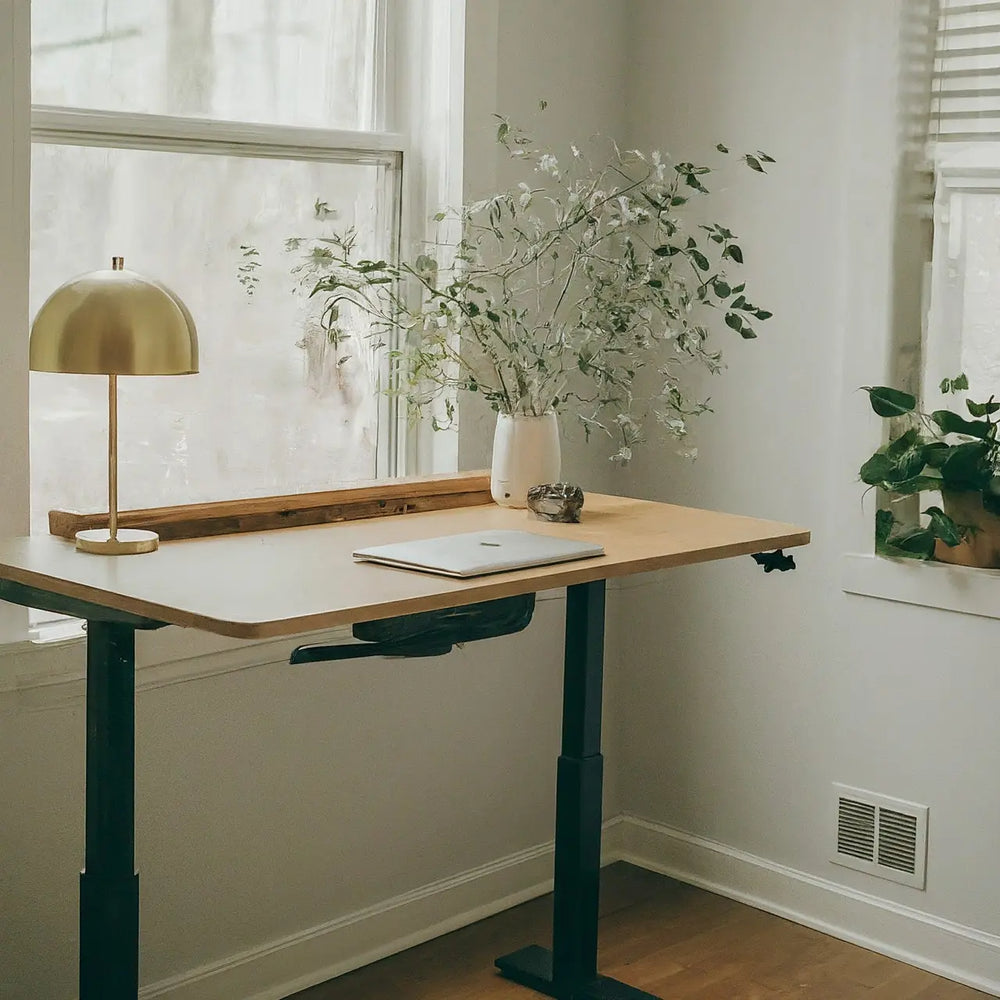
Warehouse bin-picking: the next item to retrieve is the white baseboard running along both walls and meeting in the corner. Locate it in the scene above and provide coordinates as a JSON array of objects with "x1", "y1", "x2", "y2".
[{"x1": 139, "y1": 815, "x2": 1000, "y2": 1000}]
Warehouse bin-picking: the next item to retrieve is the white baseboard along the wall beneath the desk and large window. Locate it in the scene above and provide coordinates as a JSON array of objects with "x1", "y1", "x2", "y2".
[{"x1": 139, "y1": 817, "x2": 621, "y2": 1000}]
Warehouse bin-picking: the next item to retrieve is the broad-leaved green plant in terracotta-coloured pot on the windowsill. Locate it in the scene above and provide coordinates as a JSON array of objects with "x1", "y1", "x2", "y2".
[{"x1": 860, "y1": 375, "x2": 1000, "y2": 568}]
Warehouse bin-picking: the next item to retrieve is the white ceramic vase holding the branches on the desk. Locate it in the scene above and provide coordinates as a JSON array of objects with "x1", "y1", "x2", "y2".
[{"x1": 490, "y1": 413, "x2": 561, "y2": 507}]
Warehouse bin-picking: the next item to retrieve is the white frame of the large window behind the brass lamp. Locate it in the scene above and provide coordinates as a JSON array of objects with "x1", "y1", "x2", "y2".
[{"x1": 0, "y1": 0, "x2": 465, "y2": 663}]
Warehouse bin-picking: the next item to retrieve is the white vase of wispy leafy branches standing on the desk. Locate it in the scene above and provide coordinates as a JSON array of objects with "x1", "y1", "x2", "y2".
[{"x1": 270, "y1": 116, "x2": 773, "y2": 507}]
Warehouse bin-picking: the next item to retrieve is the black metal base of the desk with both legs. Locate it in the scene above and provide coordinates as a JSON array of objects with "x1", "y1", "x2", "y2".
[{"x1": 0, "y1": 580, "x2": 656, "y2": 1000}]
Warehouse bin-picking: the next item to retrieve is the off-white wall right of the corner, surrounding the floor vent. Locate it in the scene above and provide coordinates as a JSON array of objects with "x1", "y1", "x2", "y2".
[{"x1": 616, "y1": 0, "x2": 1000, "y2": 989}]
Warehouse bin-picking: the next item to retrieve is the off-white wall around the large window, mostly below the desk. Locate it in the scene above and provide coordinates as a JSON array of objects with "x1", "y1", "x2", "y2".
[{"x1": 0, "y1": 0, "x2": 624, "y2": 1000}]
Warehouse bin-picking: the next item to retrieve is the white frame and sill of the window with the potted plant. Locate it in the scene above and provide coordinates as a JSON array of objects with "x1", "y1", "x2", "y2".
[{"x1": 831, "y1": 4, "x2": 1000, "y2": 618}]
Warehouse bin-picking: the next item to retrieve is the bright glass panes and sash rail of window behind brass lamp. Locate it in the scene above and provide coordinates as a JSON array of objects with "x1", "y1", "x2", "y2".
[{"x1": 30, "y1": 0, "x2": 400, "y2": 531}]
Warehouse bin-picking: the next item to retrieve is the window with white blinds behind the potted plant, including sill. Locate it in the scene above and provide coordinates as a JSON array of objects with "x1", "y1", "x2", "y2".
[{"x1": 841, "y1": 0, "x2": 1000, "y2": 618}]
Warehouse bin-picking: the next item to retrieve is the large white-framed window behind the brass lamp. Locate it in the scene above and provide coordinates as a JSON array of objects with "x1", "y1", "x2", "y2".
[{"x1": 0, "y1": 0, "x2": 465, "y2": 642}]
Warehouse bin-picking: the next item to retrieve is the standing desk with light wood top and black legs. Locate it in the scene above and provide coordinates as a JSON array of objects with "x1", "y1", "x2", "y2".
[{"x1": 0, "y1": 494, "x2": 809, "y2": 1000}]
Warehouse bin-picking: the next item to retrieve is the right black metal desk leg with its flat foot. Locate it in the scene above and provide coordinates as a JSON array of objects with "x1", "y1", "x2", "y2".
[{"x1": 496, "y1": 580, "x2": 657, "y2": 1000}]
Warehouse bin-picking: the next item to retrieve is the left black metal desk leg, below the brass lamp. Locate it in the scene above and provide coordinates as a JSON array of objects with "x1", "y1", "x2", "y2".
[{"x1": 80, "y1": 621, "x2": 139, "y2": 1000}]
